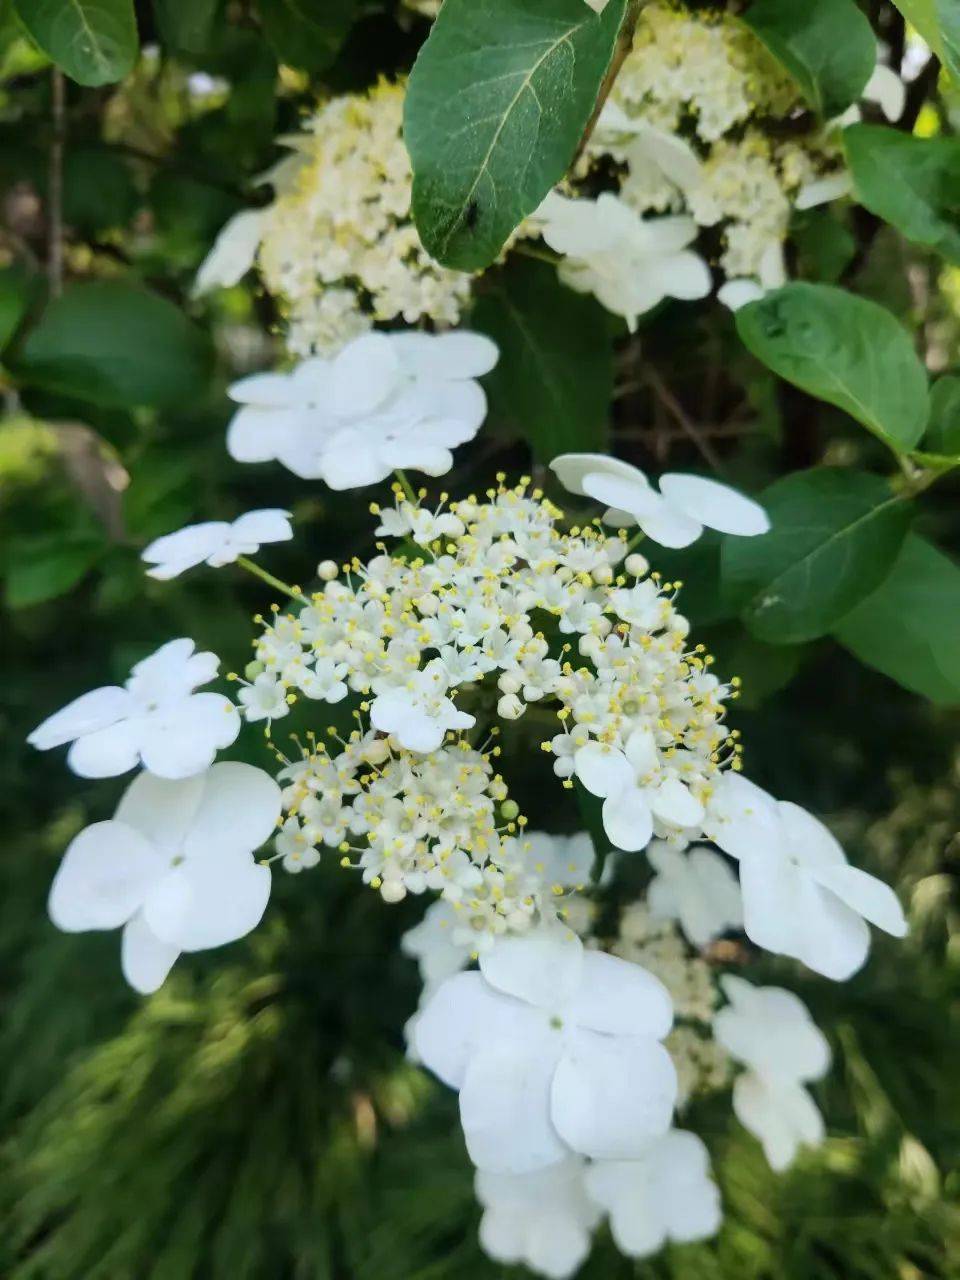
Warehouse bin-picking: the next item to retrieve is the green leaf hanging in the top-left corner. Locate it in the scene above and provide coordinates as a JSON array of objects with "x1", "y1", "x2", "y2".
[{"x1": 14, "y1": 0, "x2": 140, "y2": 87}]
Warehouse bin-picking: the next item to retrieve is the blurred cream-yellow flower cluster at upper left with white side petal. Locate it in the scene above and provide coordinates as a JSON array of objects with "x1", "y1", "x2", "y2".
[{"x1": 197, "y1": 81, "x2": 471, "y2": 356}]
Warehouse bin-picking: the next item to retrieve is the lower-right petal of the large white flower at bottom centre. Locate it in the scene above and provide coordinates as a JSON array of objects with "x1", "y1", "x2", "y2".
[{"x1": 550, "y1": 1030, "x2": 677, "y2": 1160}]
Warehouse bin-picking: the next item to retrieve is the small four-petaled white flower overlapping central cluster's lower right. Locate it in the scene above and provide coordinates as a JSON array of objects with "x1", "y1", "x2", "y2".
[{"x1": 573, "y1": 730, "x2": 704, "y2": 854}]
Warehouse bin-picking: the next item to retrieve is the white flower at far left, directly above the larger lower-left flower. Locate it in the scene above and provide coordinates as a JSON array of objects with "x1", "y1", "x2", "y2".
[{"x1": 27, "y1": 639, "x2": 241, "y2": 778}]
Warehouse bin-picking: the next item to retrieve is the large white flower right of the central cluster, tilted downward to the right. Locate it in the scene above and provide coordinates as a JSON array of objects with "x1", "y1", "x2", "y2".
[{"x1": 704, "y1": 773, "x2": 908, "y2": 980}]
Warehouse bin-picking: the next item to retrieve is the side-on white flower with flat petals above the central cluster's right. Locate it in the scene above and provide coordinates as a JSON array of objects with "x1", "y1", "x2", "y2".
[{"x1": 550, "y1": 453, "x2": 771, "y2": 547}]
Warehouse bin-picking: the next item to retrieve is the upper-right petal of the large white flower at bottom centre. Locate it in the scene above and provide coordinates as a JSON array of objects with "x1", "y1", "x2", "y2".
[{"x1": 571, "y1": 951, "x2": 673, "y2": 1039}]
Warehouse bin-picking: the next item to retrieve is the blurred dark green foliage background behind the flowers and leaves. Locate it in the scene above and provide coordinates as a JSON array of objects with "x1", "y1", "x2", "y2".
[{"x1": 0, "y1": 3, "x2": 960, "y2": 1280}]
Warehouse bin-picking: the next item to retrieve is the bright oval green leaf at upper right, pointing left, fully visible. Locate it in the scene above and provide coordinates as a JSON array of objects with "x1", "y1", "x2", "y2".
[{"x1": 736, "y1": 282, "x2": 928, "y2": 452}]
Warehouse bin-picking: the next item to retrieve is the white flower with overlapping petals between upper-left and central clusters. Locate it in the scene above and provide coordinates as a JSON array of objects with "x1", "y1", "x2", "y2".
[{"x1": 227, "y1": 332, "x2": 498, "y2": 489}]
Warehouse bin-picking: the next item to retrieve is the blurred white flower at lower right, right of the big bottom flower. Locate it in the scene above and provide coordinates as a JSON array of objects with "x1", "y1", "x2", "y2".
[{"x1": 713, "y1": 974, "x2": 829, "y2": 1171}]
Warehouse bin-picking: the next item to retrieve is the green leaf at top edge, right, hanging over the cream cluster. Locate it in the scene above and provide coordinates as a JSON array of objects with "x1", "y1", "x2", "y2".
[{"x1": 744, "y1": 0, "x2": 877, "y2": 119}]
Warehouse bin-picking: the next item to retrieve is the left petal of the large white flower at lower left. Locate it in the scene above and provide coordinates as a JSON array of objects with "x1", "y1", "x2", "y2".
[{"x1": 47, "y1": 820, "x2": 166, "y2": 933}]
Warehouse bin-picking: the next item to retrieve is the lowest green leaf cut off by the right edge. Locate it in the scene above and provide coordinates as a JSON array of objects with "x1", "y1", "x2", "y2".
[{"x1": 835, "y1": 534, "x2": 960, "y2": 705}]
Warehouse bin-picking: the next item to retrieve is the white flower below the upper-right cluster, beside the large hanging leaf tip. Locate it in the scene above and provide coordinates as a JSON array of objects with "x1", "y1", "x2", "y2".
[{"x1": 532, "y1": 192, "x2": 713, "y2": 330}]
